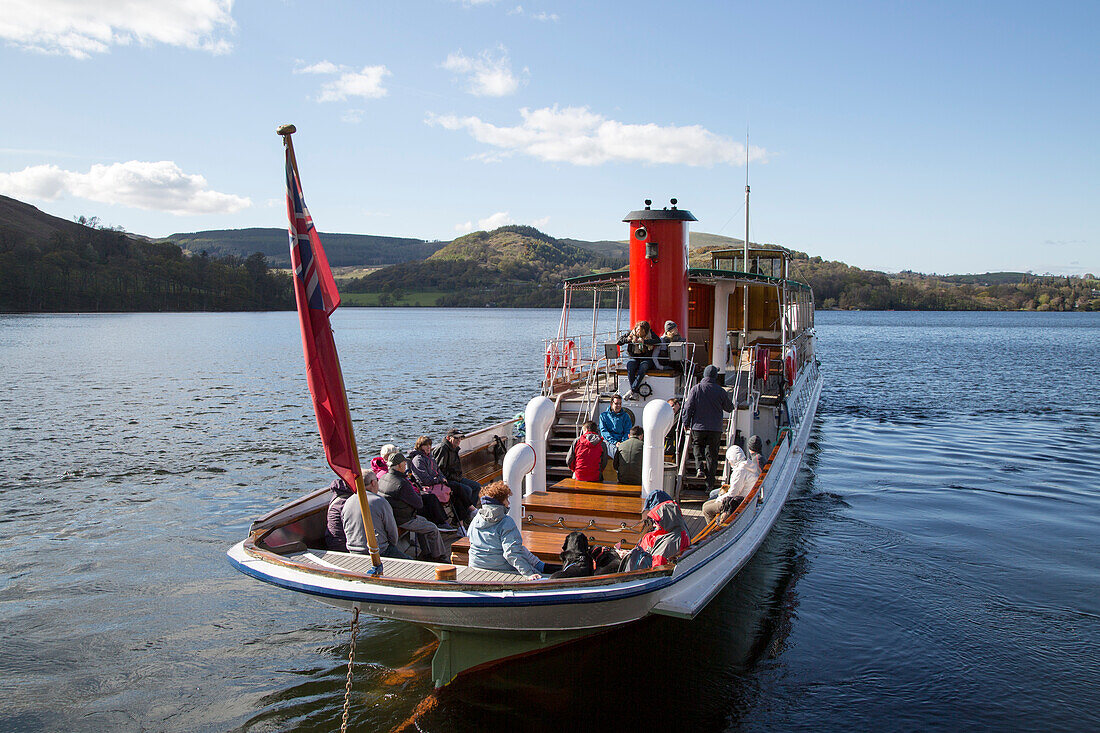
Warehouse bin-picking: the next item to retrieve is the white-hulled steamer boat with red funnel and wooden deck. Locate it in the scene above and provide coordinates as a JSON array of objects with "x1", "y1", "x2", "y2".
[{"x1": 229, "y1": 131, "x2": 822, "y2": 687}]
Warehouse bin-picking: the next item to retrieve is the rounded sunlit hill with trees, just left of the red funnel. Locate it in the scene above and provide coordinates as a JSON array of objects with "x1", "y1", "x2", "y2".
[{"x1": 343, "y1": 226, "x2": 622, "y2": 307}]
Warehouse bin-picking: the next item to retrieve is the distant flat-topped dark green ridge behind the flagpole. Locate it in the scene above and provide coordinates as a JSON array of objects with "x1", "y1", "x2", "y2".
[{"x1": 163, "y1": 228, "x2": 446, "y2": 267}]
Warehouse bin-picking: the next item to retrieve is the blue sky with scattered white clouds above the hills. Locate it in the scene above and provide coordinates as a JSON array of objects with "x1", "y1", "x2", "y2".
[{"x1": 0, "y1": 0, "x2": 1100, "y2": 274}]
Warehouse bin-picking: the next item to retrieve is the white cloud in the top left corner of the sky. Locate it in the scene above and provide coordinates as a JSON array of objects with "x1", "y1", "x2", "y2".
[{"x1": 0, "y1": 0, "x2": 235, "y2": 58}]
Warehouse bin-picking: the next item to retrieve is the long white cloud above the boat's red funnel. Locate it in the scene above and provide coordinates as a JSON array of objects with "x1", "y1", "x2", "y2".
[{"x1": 427, "y1": 106, "x2": 767, "y2": 167}]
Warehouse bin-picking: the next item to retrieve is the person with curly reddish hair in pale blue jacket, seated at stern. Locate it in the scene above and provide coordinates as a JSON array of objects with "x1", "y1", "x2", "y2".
[{"x1": 470, "y1": 481, "x2": 560, "y2": 580}]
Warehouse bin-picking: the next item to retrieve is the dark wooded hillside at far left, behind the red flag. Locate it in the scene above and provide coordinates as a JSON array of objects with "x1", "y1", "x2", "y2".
[{"x1": 0, "y1": 196, "x2": 294, "y2": 313}]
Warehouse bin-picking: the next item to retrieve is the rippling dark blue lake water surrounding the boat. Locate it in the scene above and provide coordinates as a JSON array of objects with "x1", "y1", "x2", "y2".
[{"x1": 0, "y1": 308, "x2": 1100, "y2": 733}]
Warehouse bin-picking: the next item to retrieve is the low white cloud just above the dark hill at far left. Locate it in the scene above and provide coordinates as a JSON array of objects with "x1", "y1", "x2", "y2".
[{"x1": 0, "y1": 161, "x2": 252, "y2": 215}]
